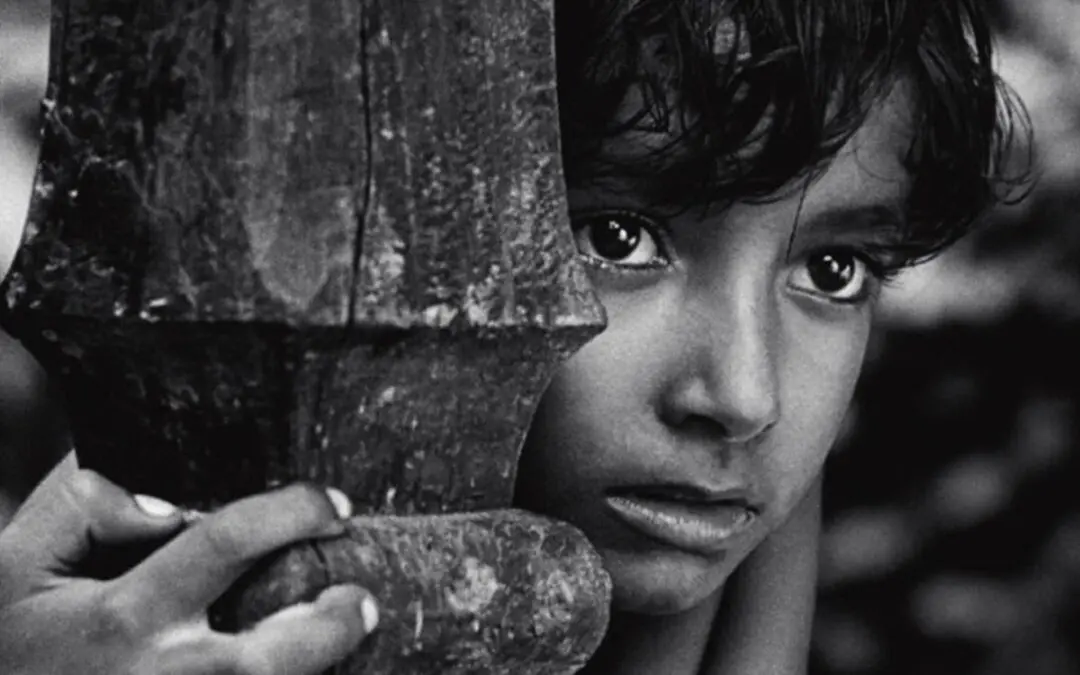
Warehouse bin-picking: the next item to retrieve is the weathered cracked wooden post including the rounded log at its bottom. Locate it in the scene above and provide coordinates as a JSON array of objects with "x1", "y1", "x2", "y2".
[{"x1": 2, "y1": 0, "x2": 610, "y2": 675}]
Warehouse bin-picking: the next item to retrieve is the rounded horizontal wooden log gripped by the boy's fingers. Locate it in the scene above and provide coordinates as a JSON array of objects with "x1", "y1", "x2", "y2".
[{"x1": 214, "y1": 510, "x2": 611, "y2": 675}]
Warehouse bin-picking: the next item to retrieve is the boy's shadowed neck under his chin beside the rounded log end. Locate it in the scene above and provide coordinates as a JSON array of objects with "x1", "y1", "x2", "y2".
[{"x1": 579, "y1": 591, "x2": 721, "y2": 675}]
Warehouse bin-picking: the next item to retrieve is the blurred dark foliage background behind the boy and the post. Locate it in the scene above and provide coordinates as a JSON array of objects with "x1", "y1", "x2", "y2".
[{"x1": 0, "y1": 0, "x2": 1080, "y2": 675}]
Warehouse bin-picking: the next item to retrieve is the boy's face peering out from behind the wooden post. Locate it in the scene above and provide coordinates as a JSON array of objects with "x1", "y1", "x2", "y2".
[{"x1": 518, "y1": 87, "x2": 909, "y2": 613}]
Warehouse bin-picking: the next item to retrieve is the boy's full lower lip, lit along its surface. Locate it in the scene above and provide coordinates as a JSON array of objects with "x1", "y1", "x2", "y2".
[{"x1": 605, "y1": 497, "x2": 756, "y2": 554}]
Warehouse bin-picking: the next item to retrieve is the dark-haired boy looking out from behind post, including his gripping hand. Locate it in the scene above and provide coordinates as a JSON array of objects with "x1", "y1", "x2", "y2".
[{"x1": 0, "y1": 0, "x2": 1016, "y2": 675}]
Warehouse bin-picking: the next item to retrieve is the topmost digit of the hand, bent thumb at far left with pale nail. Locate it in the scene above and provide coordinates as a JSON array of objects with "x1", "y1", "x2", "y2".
[{"x1": 0, "y1": 453, "x2": 184, "y2": 573}]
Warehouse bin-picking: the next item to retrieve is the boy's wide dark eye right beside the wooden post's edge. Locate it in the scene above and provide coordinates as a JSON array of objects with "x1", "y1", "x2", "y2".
[{"x1": 571, "y1": 212, "x2": 671, "y2": 269}]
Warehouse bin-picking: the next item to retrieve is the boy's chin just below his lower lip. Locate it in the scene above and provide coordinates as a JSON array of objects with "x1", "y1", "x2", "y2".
[{"x1": 600, "y1": 551, "x2": 730, "y2": 615}]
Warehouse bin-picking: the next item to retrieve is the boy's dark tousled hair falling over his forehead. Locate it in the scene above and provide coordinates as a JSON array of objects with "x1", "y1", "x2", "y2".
[{"x1": 556, "y1": 0, "x2": 1031, "y2": 262}]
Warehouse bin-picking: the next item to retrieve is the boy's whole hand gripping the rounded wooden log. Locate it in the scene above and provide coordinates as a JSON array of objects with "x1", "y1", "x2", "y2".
[{"x1": 0, "y1": 455, "x2": 378, "y2": 675}]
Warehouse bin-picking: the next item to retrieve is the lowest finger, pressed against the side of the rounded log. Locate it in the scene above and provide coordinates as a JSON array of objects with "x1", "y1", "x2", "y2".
[{"x1": 234, "y1": 585, "x2": 378, "y2": 675}]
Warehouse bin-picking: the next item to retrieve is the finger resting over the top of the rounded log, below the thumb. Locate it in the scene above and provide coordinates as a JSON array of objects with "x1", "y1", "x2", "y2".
[{"x1": 113, "y1": 485, "x2": 347, "y2": 625}]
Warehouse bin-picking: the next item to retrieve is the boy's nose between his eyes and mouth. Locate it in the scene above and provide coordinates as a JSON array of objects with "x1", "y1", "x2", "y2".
[{"x1": 663, "y1": 289, "x2": 780, "y2": 443}]
